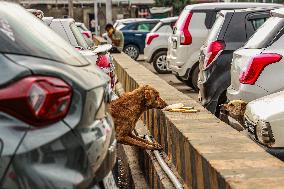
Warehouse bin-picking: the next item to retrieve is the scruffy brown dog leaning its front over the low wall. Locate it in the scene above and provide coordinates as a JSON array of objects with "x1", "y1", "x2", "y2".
[{"x1": 110, "y1": 85, "x2": 167, "y2": 150}]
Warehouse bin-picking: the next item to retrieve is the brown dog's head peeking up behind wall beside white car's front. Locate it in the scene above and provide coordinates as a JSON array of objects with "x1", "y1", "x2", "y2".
[{"x1": 221, "y1": 100, "x2": 247, "y2": 131}]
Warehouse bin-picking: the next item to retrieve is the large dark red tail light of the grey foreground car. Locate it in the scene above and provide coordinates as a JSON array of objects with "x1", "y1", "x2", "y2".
[{"x1": 0, "y1": 76, "x2": 72, "y2": 126}]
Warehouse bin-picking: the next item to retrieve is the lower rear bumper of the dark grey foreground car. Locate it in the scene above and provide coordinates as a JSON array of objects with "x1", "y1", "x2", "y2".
[{"x1": 0, "y1": 114, "x2": 116, "y2": 189}]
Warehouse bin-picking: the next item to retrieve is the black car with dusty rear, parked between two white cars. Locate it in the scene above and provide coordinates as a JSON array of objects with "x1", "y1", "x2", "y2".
[{"x1": 198, "y1": 6, "x2": 282, "y2": 115}]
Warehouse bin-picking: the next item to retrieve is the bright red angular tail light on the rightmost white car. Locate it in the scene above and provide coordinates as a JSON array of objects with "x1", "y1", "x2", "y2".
[{"x1": 239, "y1": 53, "x2": 282, "y2": 85}]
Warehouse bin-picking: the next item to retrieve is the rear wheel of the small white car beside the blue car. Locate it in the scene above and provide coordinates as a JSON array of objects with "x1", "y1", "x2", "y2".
[{"x1": 153, "y1": 51, "x2": 170, "y2": 74}]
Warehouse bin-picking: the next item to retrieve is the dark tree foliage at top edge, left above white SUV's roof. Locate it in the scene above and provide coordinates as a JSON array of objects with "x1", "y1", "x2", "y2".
[{"x1": 155, "y1": 0, "x2": 191, "y2": 15}]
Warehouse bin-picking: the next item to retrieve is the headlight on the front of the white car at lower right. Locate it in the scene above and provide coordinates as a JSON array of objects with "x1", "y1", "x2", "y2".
[{"x1": 255, "y1": 120, "x2": 275, "y2": 147}]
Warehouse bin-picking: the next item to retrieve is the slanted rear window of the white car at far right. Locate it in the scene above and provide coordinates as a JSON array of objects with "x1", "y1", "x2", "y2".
[{"x1": 244, "y1": 17, "x2": 284, "y2": 49}]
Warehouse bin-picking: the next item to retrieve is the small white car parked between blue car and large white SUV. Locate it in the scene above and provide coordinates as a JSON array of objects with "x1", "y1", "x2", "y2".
[{"x1": 144, "y1": 17, "x2": 178, "y2": 74}]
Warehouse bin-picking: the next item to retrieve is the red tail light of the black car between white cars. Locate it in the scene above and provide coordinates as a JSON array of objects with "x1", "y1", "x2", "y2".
[{"x1": 205, "y1": 41, "x2": 226, "y2": 67}]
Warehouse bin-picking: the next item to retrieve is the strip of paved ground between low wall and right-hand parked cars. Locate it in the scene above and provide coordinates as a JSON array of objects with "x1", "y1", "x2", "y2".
[{"x1": 137, "y1": 57, "x2": 198, "y2": 101}]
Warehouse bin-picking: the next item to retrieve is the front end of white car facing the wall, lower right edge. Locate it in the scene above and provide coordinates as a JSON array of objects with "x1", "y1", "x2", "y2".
[{"x1": 244, "y1": 91, "x2": 284, "y2": 148}]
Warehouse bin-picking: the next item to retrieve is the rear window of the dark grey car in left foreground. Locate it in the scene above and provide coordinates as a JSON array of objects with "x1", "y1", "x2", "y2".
[{"x1": 0, "y1": 3, "x2": 89, "y2": 66}]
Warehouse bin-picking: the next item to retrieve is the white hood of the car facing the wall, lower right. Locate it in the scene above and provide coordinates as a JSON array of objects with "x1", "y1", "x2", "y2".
[{"x1": 245, "y1": 91, "x2": 284, "y2": 122}]
